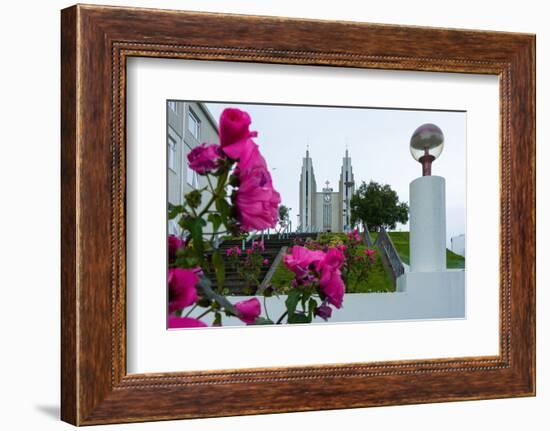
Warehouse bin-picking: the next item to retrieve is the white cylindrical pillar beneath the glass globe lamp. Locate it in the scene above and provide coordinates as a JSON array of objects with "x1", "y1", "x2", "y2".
[{"x1": 409, "y1": 176, "x2": 447, "y2": 272}]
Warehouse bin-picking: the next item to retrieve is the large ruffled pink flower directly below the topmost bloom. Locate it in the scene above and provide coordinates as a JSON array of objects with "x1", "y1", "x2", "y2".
[{"x1": 235, "y1": 152, "x2": 281, "y2": 232}]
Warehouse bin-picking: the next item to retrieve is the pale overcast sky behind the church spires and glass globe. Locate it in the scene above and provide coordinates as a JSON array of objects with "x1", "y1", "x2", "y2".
[{"x1": 207, "y1": 103, "x2": 466, "y2": 243}]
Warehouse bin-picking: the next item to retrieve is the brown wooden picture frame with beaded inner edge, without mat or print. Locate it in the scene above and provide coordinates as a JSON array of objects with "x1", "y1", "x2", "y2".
[{"x1": 61, "y1": 5, "x2": 535, "y2": 425}]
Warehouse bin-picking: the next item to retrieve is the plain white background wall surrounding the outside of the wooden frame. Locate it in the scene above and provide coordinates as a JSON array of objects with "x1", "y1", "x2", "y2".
[{"x1": 0, "y1": 0, "x2": 550, "y2": 431}]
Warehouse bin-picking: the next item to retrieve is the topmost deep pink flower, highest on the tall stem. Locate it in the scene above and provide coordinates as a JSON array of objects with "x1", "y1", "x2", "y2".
[{"x1": 219, "y1": 108, "x2": 258, "y2": 160}]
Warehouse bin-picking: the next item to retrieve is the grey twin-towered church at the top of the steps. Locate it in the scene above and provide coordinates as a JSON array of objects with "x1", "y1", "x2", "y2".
[{"x1": 298, "y1": 149, "x2": 355, "y2": 232}]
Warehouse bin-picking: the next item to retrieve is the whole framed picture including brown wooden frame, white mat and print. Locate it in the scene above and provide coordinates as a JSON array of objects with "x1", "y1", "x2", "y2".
[{"x1": 61, "y1": 5, "x2": 535, "y2": 425}]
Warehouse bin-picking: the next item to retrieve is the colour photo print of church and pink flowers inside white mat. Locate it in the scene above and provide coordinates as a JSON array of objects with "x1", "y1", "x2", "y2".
[{"x1": 166, "y1": 100, "x2": 467, "y2": 330}]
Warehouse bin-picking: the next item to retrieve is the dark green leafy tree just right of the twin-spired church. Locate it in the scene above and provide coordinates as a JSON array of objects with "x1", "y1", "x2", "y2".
[{"x1": 350, "y1": 181, "x2": 409, "y2": 232}]
